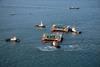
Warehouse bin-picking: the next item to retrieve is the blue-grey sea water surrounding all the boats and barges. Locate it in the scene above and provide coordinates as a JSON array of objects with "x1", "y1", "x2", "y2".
[{"x1": 0, "y1": 0, "x2": 100, "y2": 67}]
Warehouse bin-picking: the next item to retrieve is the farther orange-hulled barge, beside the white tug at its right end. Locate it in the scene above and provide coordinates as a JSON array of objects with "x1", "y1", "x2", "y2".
[{"x1": 51, "y1": 24, "x2": 68, "y2": 32}]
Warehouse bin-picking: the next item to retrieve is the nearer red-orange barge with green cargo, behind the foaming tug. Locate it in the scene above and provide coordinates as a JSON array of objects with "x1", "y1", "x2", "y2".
[{"x1": 42, "y1": 33, "x2": 63, "y2": 43}]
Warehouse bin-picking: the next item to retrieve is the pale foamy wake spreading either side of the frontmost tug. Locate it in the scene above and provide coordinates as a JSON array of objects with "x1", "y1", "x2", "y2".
[{"x1": 37, "y1": 45, "x2": 83, "y2": 51}]
